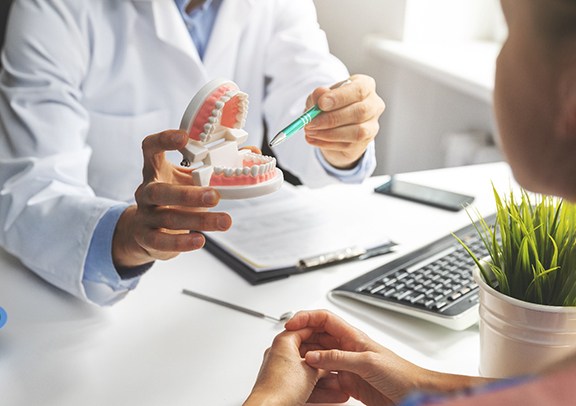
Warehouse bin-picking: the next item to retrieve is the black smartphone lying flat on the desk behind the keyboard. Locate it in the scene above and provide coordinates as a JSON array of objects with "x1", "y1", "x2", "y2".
[{"x1": 374, "y1": 177, "x2": 474, "y2": 211}]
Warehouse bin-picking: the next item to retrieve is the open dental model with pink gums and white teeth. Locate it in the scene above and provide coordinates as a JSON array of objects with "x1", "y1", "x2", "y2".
[{"x1": 180, "y1": 79, "x2": 284, "y2": 199}]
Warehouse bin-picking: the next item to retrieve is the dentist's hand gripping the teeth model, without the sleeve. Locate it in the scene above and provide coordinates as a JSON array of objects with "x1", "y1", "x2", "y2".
[{"x1": 112, "y1": 130, "x2": 232, "y2": 267}]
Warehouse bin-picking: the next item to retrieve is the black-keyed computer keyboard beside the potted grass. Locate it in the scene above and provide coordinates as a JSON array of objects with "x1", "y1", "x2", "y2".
[{"x1": 330, "y1": 215, "x2": 495, "y2": 330}]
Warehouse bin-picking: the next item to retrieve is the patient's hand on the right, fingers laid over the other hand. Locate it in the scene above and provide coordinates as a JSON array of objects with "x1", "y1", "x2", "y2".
[{"x1": 286, "y1": 310, "x2": 486, "y2": 405}]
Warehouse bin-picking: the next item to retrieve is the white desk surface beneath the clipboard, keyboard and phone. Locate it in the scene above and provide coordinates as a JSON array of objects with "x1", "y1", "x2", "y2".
[{"x1": 0, "y1": 164, "x2": 513, "y2": 406}]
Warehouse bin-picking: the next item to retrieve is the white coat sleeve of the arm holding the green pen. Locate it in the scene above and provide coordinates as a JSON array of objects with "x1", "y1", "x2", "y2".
[{"x1": 264, "y1": 0, "x2": 376, "y2": 187}]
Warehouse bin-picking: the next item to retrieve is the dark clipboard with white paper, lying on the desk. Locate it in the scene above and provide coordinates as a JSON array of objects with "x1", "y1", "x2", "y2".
[{"x1": 204, "y1": 184, "x2": 396, "y2": 285}]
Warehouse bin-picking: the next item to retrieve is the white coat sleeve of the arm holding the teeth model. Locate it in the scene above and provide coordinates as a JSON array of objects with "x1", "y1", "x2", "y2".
[{"x1": 0, "y1": 0, "x2": 118, "y2": 300}]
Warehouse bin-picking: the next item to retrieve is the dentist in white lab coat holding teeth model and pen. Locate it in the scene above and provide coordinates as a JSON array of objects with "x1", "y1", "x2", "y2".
[{"x1": 0, "y1": 0, "x2": 384, "y2": 305}]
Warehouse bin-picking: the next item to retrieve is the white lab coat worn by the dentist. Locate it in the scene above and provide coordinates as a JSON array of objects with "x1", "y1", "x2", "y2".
[{"x1": 0, "y1": 0, "x2": 356, "y2": 298}]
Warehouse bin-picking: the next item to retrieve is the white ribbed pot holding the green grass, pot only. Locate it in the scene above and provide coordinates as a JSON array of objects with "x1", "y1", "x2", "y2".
[{"x1": 474, "y1": 268, "x2": 576, "y2": 378}]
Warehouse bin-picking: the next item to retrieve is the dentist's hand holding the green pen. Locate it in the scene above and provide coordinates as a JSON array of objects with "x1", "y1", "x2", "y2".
[{"x1": 305, "y1": 75, "x2": 385, "y2": 169}]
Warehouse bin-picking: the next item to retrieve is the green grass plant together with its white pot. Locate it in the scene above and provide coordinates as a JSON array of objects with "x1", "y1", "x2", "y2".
[{"x1": 460, "y1": 187, "x2": 576, "y2": 378}]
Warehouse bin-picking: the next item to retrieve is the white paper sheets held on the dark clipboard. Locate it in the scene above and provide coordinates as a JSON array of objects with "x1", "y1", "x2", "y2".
[{"x1": 207, "y1": 185, "x2": 390, "y2": 272}]
